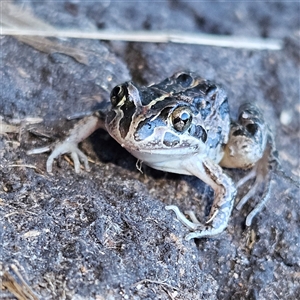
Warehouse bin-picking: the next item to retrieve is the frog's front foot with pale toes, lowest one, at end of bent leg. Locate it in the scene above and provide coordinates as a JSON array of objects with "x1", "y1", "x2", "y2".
[{"x1": 165, "y1": 205, "x2": 228, "y2": 241}]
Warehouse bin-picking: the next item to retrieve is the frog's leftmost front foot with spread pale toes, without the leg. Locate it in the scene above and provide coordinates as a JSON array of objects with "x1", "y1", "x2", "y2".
[{"x1": 27, "y1": 139, "x2": 90, "y2": 173}]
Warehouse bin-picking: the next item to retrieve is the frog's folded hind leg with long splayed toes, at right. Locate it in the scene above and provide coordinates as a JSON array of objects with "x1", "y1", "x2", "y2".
[{"x1": 221, "y1": 103, "x2": 279, "y2": 226}]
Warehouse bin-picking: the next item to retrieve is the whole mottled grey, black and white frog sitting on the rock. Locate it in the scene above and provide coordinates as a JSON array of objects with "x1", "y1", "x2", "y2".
[{"x1": 29, "y1": 71, "x2": 278, "y2": 240}]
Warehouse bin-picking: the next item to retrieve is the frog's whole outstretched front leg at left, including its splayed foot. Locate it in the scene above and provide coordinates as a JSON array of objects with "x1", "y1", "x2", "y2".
[{"x1": 27, "y1": 114, "x2": 105, "y2": 173}]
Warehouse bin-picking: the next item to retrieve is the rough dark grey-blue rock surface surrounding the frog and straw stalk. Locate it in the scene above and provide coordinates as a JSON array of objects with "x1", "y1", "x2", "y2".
[{"x1": 0, "y1": 0, "x2": 300, "y2": 300}]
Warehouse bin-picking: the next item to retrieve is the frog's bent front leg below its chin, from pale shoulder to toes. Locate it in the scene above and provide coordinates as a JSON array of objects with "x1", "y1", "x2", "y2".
[{"x1": 166, "y1": 159, "x2": 236, "y2": 240}]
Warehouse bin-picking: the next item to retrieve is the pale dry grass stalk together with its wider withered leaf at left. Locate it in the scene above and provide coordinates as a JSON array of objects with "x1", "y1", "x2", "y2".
[{"x1": 1, "y1": 3, "x2": 283, "y2": 50}]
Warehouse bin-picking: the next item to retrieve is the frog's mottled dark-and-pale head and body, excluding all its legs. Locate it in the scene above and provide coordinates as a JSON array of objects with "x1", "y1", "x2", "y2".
[{"x1": 105, "y1": 73, "x2": 230, "y2": 175}]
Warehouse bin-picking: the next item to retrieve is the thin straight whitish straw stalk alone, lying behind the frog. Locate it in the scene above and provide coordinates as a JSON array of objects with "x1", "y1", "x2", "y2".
[{"x1": 0, "y1": 27, "x2": 283, "y2": 50}]
